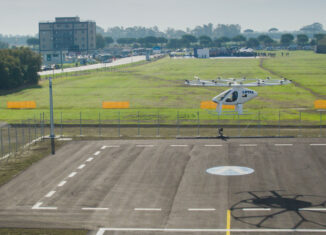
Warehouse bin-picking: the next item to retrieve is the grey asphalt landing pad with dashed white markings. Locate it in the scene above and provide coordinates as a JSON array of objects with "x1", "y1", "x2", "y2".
[{"x1": 0, "y1": 139, "x2": 326, "y2": 235}]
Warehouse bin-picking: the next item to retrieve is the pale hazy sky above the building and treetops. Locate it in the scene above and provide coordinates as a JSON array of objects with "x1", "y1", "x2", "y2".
[{"x1": 0, "y1": 0, "x2": 326, "y2": 35}]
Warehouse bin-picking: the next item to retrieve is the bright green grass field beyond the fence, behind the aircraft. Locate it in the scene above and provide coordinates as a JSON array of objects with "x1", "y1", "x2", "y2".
[{"x1": 0, "y1": 51, "x2": 326, "y2": 122}]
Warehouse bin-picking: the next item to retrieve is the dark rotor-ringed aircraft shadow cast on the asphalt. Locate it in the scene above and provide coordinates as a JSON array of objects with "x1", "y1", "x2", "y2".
[{"x1": 230, "y1": 190, "x2": 326, "y2": 229}]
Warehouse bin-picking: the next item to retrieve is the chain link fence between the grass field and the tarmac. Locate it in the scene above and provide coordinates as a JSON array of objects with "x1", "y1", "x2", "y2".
[{"x1": 0, "y1": 110, "x2": 326, "y2": 160}]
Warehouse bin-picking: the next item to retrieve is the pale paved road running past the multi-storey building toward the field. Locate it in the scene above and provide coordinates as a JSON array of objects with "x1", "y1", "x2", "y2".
[{"x1": 38, "y1": 56, "x2": 146, "y2": 76}]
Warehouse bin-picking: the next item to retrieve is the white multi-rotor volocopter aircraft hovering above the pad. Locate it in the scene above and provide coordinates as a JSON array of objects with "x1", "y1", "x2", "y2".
[{"x1": 185, "y1": 76, "x2": 292, "y2": 114}]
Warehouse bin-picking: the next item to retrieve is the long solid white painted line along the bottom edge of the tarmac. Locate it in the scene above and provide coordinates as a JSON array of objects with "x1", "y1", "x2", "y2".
[{"x1": 96, "y1": 228, "x2": 326, "y2": 235}]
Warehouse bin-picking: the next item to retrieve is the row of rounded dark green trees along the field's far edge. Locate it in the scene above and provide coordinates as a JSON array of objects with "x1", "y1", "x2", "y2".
[{"x1": 96, "y1": 33, "x2": 325, "y2": 49}]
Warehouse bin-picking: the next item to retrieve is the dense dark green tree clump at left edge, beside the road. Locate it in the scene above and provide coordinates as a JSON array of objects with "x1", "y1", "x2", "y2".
[{"x1": 0, "y1": 48, "x2": 42, "y2": 90}]
